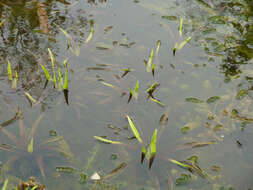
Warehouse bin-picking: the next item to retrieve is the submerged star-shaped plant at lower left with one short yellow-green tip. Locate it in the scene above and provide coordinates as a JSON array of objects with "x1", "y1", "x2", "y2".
[{"x1": 0, "y1": 109, "x2": 73, "y2": 177}]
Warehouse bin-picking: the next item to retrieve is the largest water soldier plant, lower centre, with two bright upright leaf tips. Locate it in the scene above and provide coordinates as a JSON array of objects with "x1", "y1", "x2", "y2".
[{"x1": 94, "y1": 111, "x2": 220, "y2": 189}]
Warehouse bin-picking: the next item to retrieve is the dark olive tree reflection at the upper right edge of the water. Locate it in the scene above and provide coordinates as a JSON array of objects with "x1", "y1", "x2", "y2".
[{"x1": 218, "y1": 0, "x2": 253, "y2": 77}]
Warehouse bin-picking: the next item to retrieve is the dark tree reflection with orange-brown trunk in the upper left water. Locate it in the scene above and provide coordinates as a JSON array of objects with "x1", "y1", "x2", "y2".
[{"x1": 0, "y1": 0, "x2": 90, "y2": 106}]
